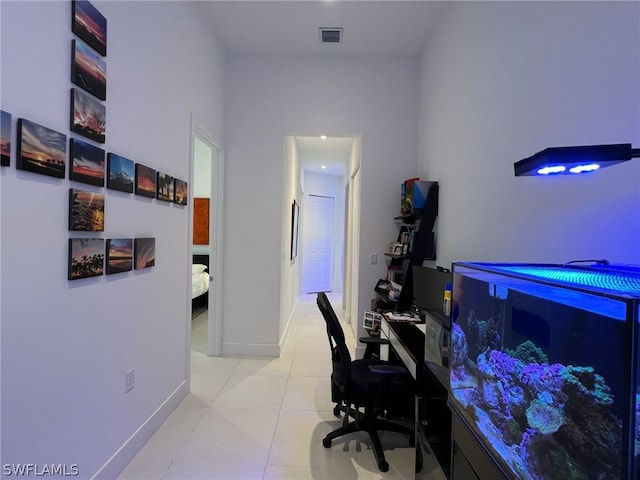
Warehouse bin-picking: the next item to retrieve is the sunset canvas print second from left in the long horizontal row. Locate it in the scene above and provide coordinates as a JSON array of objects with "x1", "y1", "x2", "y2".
[{"x1": 16, "y1": 118, "x2": 67, "y2": 178}]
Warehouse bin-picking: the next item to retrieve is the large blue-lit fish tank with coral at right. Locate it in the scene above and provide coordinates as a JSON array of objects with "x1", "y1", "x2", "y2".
[{"x1": 450, "y1": 262, "x2": 640, "y2": 480}]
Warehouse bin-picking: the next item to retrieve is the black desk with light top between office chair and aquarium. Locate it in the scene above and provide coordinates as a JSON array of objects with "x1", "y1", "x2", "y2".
[{"x1": 380, "y1": 316, "x2": 452, "y2": 479}]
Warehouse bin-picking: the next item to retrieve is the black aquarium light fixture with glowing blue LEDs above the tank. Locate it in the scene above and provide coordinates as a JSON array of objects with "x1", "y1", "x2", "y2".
[{"x1": 513, "y1": 143, "x2": 640, "y2": 177}]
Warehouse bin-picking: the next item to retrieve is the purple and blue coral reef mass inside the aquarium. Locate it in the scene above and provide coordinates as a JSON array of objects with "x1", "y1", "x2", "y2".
[{"x1": 451, "y1": 320, "x2": 620, "y2": 480}]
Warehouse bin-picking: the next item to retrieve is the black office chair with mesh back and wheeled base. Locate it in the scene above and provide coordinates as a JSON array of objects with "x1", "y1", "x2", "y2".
[{"x1": 317, "y1": 292, "x2": 415, "y2": 472}]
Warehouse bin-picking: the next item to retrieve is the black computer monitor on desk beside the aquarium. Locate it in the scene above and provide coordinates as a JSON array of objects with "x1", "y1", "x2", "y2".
[{"x1": 412, "y1": 265, "x2": 452, "y2": 329}]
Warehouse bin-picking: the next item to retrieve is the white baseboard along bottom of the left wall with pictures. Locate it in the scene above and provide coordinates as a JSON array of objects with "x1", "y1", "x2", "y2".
[{"x1": 91, "y1": 380, "x2": 189, "y2": 480}]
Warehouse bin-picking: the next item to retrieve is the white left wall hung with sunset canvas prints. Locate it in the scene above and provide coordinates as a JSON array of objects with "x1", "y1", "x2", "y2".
[{"x1": 0, "y1": 1, "x2": 224, "y2": 478}]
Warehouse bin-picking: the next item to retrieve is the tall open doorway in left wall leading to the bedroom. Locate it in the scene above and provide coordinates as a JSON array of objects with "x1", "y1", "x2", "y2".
[{"x1": 189, "y1": 116, "x2": 224, "y2": 356}]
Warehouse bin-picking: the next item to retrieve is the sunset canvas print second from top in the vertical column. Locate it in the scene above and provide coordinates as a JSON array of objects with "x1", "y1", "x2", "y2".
[{"x1": 71, "y1": 39, "x2": 107, "y2": 100}]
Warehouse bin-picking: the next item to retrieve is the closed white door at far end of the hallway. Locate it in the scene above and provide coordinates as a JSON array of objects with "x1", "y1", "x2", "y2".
[{"x1": 302, "y1": 195, "x2": 334, "y2": 293}]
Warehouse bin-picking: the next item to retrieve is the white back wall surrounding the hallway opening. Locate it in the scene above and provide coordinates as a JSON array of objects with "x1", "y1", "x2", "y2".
[{"x1": 223, "y1": 55, "x2": 418, "y2": 355}]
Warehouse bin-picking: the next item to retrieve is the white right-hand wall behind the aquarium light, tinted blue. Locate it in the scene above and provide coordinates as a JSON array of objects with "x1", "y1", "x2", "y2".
[{"x1": 418, "y1": 1, "x2": 640, "y2": 265}]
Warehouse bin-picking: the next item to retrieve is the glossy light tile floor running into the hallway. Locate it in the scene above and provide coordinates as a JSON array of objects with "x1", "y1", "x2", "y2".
[{"x1": 118, "y1": 295, "x2": 443, "y2": 480}]
